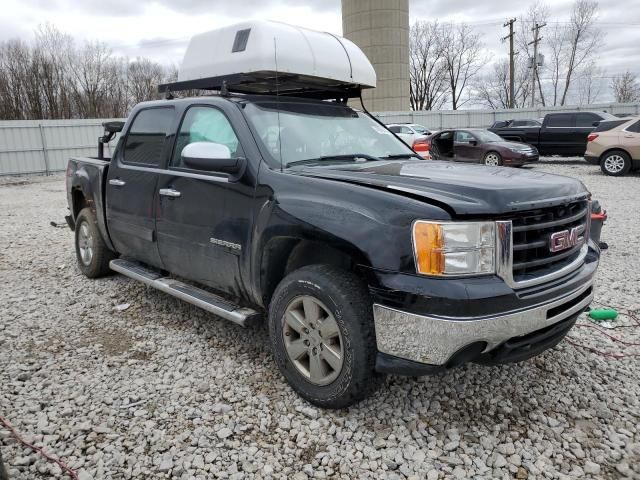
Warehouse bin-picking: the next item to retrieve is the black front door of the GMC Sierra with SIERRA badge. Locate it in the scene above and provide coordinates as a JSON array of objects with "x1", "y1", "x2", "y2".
[{"x1": 156, "y1": 105, "x2": 255, "y2": 297}]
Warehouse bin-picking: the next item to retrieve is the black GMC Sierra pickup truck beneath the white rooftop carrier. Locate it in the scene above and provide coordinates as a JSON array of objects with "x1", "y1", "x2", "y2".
[{"x1": 66, "y1": 20, "x2": 599, "y2": 408}]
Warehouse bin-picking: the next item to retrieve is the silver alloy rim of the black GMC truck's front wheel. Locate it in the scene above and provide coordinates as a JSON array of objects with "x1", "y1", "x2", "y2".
[{"x1": 282, "y1": 295, "x2": 344, "y2": 385}]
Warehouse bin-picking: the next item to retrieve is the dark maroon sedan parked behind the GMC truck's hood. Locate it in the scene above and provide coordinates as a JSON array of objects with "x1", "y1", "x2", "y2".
[{"x1": 429, "y1": 128, "x2": 538, "y2": 167}]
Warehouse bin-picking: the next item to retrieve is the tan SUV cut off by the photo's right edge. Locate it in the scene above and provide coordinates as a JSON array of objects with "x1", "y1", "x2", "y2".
[{"x1": 584, "y1": 117, "x2": 640, "y2": 177}]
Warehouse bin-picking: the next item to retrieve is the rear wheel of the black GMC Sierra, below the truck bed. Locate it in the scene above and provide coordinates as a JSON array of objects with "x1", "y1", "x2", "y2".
[{"x1": 75, "y1": 208, "x2": 116, "y2": 278}]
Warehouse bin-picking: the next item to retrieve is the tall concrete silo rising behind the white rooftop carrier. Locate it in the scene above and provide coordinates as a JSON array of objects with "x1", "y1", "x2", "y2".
[{"x1": 342, "y1": 0, "x2": 409, "y2": 112}]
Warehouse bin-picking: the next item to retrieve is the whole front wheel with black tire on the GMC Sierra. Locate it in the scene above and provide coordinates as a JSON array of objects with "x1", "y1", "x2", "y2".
[{"x1": 269, "y1": 265, "x2": 383, "y2": 408}]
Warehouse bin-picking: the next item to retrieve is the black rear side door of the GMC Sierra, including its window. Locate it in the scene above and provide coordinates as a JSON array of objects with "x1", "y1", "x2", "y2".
[{"x1": 106, "y1": 106, "x2": 175, "y2": 267}]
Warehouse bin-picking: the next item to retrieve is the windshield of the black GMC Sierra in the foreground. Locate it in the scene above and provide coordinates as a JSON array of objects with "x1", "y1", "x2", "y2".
[{"x1": 244, "y1": 102, "x2": 415, "y2": 168}]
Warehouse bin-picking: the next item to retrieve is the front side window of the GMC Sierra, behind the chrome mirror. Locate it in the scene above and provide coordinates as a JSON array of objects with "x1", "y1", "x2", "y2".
[{"x1": 171, "y1": 107, "x2": 244, "y2": 168}]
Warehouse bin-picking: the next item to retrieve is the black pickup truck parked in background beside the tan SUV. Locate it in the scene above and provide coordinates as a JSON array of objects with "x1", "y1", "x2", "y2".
[{"x1": 489, "y1": 112, "x2": 616, "y2": 157}]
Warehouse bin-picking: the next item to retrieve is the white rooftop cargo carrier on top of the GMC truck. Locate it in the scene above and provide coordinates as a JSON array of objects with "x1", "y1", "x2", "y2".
[{"x1": 159, "y1": 21, "x2": 376, "y2": 98}]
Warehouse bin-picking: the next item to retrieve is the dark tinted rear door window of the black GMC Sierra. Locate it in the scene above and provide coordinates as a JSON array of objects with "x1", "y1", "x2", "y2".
[{"x1": 124, "y1": 107, "x2": 174, "y2": 166}]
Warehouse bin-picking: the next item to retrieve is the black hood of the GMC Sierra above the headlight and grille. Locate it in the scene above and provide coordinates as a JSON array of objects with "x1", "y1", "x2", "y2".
[{"x1": 290, "y1": 160, "x2": 589, "y2": 215}]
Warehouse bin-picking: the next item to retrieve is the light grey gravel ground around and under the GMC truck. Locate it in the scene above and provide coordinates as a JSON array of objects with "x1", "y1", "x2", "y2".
[{"x1": 0, "y1": 160, "x2": 640, "y2": 480}]
